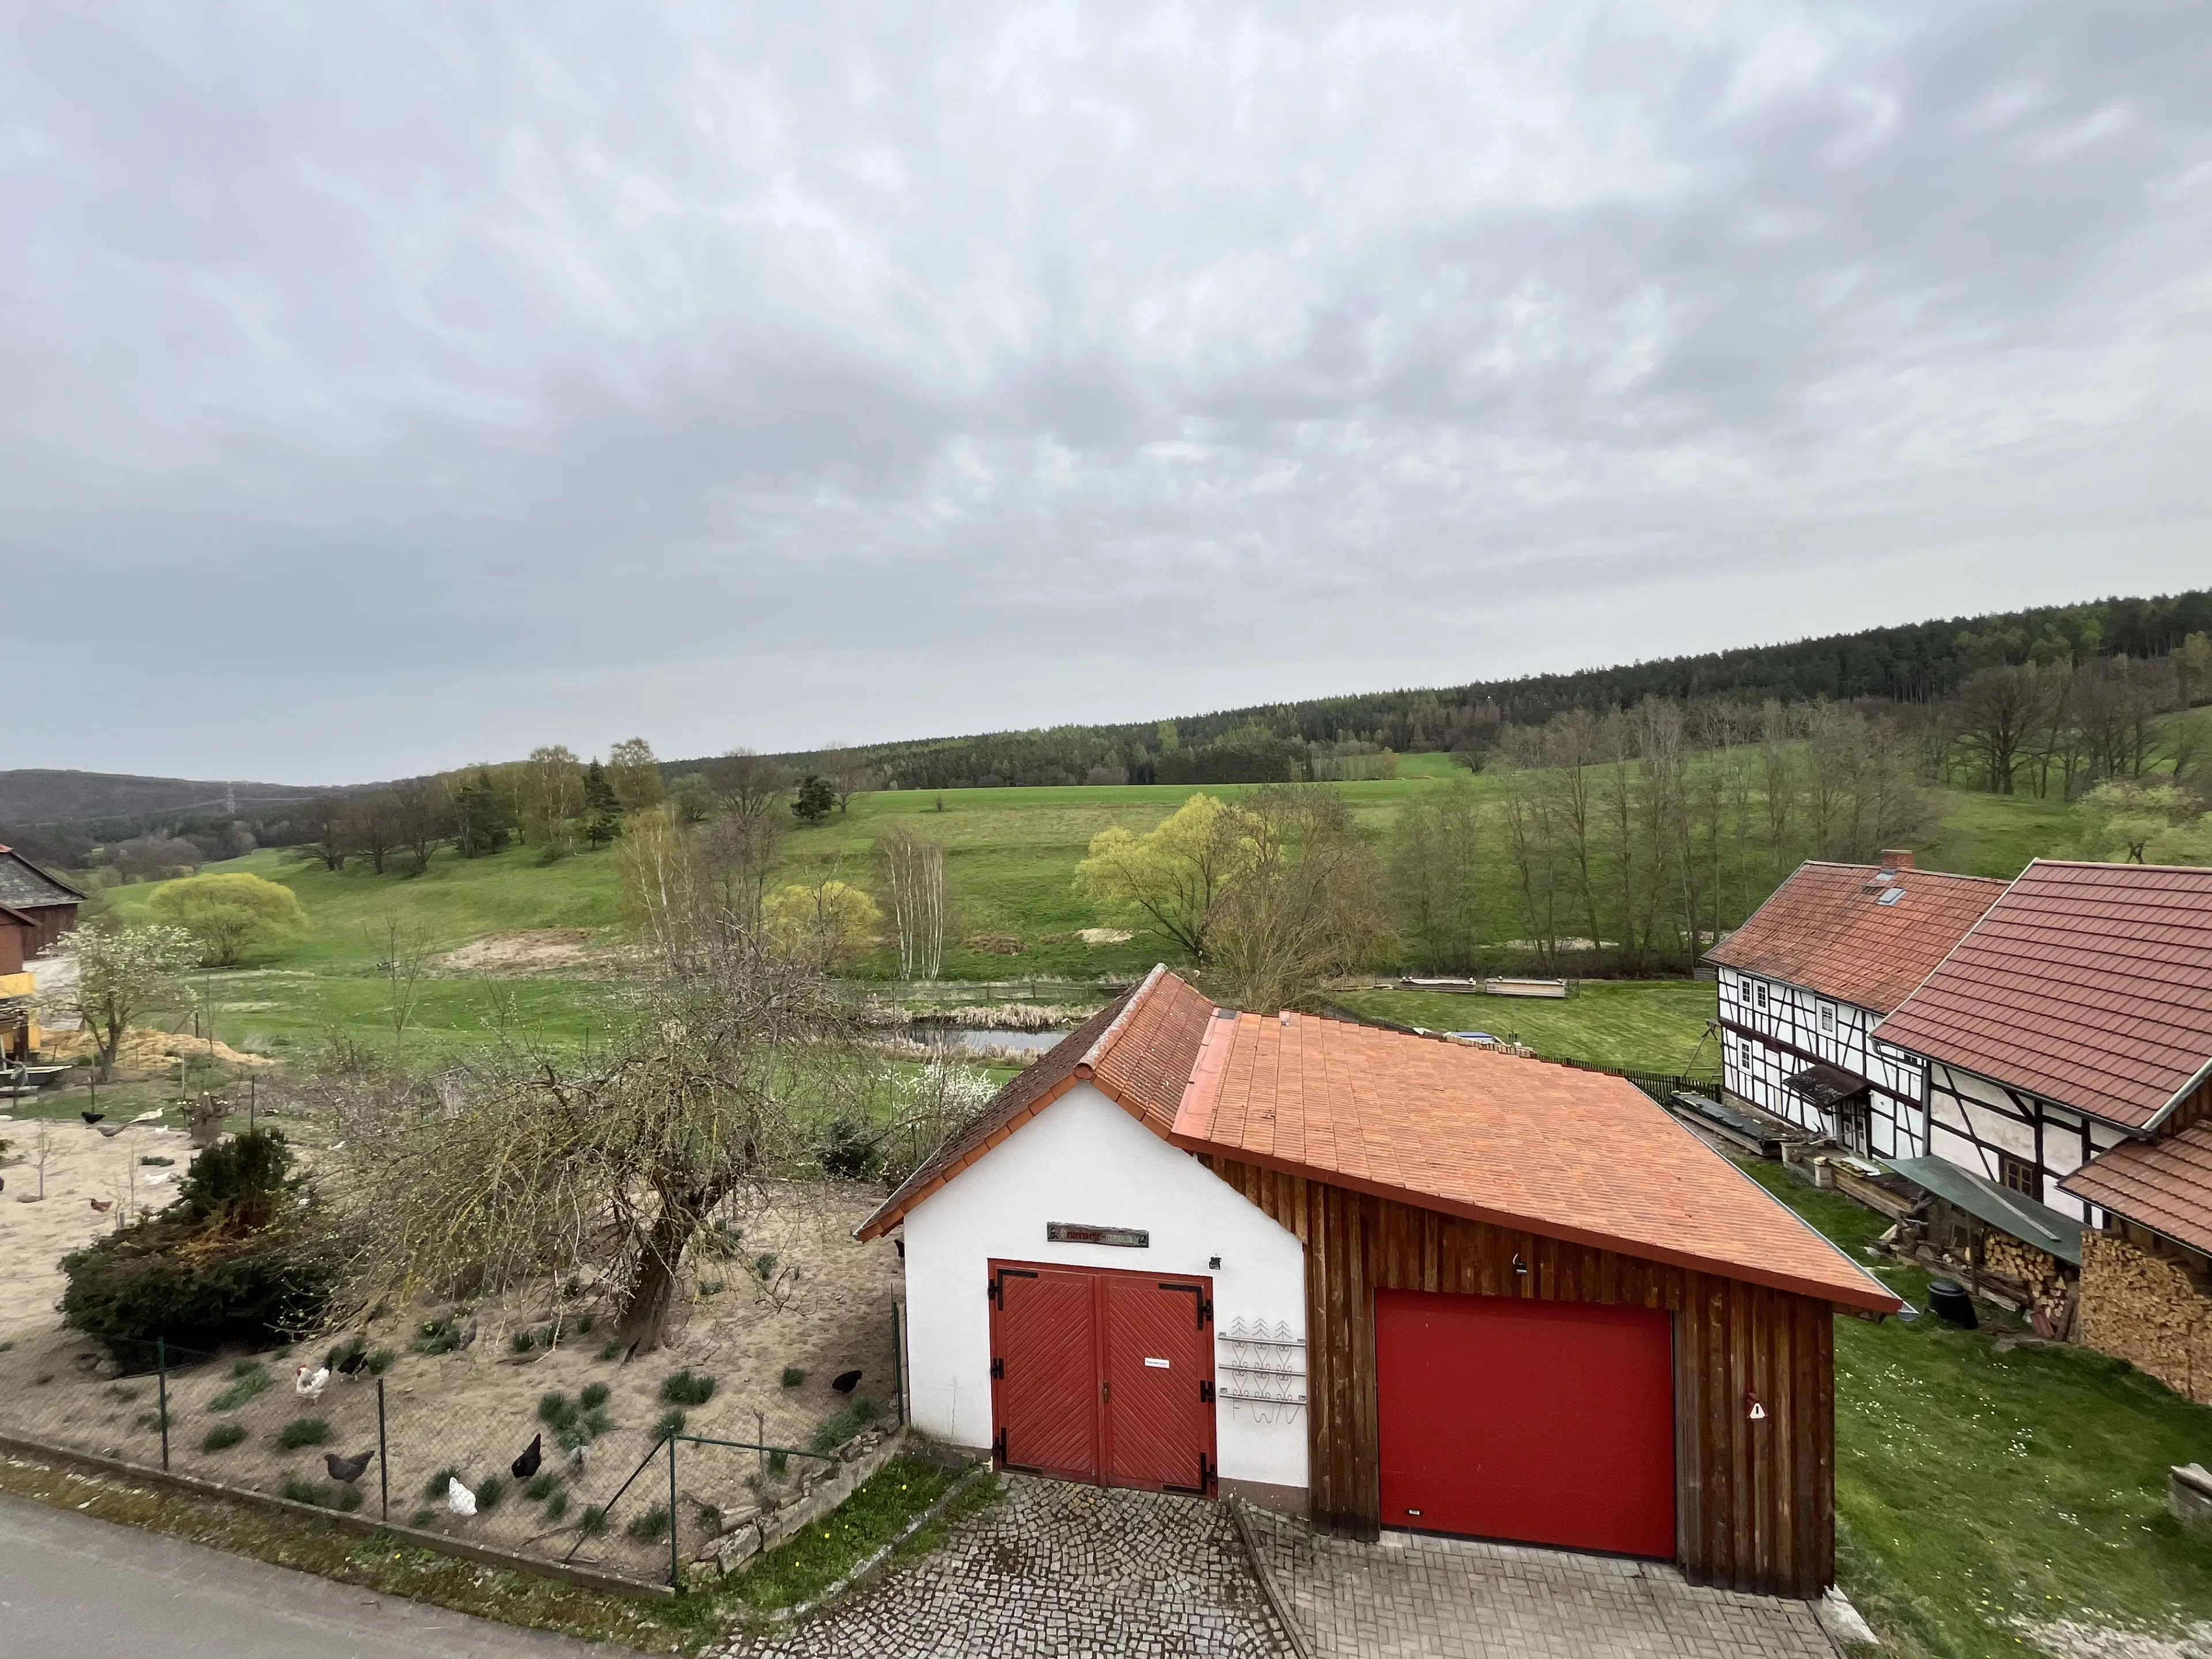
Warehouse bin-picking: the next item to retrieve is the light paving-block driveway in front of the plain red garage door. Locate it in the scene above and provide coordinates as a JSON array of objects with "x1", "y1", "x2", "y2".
[{"x1": 1252, "y1": 1511, "x2": 1836, "y2": 1659}]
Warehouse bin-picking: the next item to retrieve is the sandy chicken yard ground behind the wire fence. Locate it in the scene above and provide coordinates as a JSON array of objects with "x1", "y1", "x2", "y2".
[{"x1": 0, "y1": 1185, "x2": 898, "y2": 1573}]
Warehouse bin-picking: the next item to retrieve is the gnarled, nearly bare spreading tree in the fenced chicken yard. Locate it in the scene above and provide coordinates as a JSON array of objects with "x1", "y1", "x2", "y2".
[{"x1": 316, "y1": 914, "x2": 880, "y2": 1354}]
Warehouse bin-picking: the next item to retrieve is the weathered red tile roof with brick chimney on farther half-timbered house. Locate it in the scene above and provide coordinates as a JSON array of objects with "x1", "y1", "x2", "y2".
[{"x1": 1706, "y1": 863, "x2": 2004, "y2": 1013}]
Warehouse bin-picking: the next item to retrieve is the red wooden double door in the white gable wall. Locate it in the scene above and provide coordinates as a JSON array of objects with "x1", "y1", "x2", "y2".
[{"x1": 988, "y1": 1261, "x2": 1217, "y2": 1493}]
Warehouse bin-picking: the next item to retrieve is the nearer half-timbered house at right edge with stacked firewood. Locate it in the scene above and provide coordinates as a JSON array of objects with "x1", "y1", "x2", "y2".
[{"x1": 1876, "y1": 858, "x2": 2212, "y2": 1398}]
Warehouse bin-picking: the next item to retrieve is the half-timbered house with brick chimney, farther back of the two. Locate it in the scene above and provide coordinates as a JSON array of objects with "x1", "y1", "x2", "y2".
[{"x1": 1706, "y1": 851, "x2": 2004, "y2": 1159}]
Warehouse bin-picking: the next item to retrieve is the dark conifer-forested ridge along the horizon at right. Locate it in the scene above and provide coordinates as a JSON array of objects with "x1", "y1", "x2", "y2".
[{"x1": 743, "y1": 588, "x2": 2212, "y2": 790}]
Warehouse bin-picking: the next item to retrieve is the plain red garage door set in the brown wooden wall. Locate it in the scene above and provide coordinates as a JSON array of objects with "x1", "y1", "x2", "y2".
[{"x1": 1376, "y1": 1290, "x2": 1675, "y2": 1559}]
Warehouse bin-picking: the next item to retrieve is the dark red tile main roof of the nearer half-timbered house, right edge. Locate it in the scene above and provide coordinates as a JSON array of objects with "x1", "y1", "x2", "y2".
[{"x1": 1876, "y1": 858, "x2": 2212, "y2": 1128}]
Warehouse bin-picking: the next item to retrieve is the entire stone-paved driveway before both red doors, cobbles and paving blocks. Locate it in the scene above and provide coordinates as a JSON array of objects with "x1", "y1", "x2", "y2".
[{"x1": 726, "y1": 1475, "x2": 1836, "y2": 1659}]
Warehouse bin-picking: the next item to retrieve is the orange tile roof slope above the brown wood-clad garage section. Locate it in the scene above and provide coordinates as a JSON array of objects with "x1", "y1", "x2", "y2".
[{"x1": 1175, "y1": 1013, "x2": 1900, "y2": 1312}]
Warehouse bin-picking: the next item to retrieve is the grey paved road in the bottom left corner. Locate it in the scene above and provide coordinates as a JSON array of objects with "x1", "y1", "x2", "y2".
[{"x1": 0, "y1": 1495, "x2": 617, "y2": 1659}]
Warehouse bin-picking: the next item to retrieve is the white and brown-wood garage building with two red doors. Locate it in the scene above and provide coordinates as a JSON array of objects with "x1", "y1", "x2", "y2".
[{"x1": 861, "y1": 969, "x2": 1898, "y2": 1595}]
